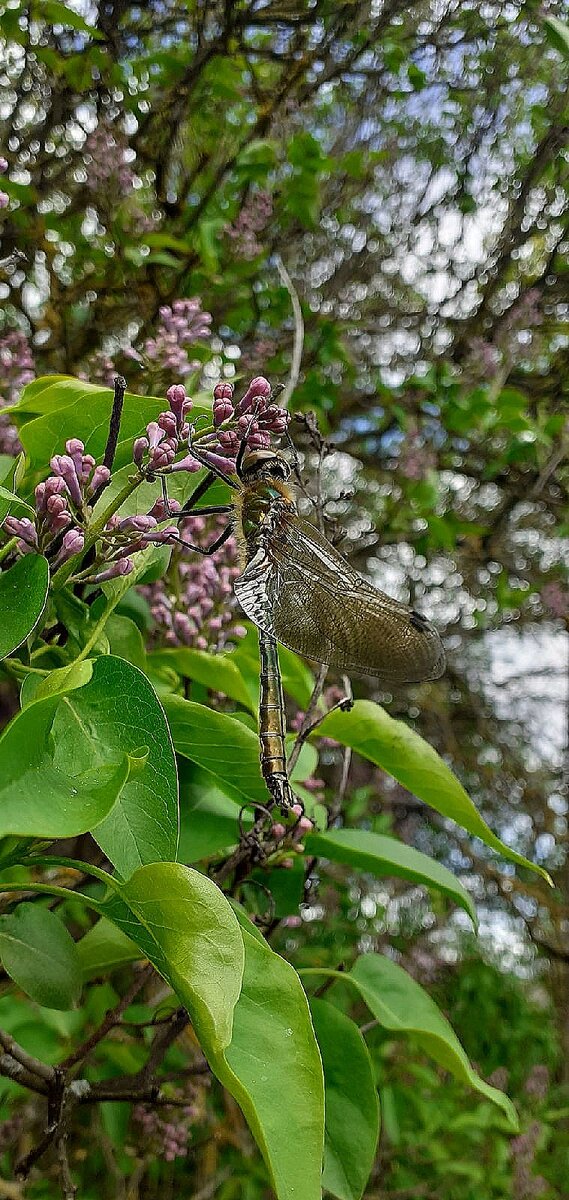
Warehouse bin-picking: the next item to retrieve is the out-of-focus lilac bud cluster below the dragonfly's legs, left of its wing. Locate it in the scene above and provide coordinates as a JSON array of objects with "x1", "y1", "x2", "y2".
[{"x1": 139, "y1": 515, "x2": 246, "y2": 650}]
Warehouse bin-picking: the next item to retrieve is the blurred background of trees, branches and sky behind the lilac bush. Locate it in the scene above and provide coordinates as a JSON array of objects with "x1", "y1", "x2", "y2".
[{"x1": 0, "y1": 0, "x2": 569, "y2": 1200}]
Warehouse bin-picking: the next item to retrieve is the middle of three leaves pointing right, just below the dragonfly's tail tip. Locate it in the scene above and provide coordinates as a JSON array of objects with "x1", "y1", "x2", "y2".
[{"x1": 304, "y1": 829, "x2": 477, "y2": 925}]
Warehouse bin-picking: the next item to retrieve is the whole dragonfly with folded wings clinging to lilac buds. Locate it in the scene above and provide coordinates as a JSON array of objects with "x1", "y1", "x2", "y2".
[{"x1": 162, "y1": 439, "x2": 444, "y2": 812}]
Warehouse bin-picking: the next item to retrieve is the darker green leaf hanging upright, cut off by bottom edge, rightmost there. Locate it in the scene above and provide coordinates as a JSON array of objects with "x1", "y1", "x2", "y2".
[{"x1": 310, "y1": 1000, "x2": 379, "y2": 1200}]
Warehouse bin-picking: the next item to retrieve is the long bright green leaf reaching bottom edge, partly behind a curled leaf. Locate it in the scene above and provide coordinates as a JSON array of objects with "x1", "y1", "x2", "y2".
[{"x1": 204, "y1": 916, "x2": 324, "y2": 1200}]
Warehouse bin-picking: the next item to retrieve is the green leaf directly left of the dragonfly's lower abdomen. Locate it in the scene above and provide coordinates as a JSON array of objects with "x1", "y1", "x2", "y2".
[{"x1": 164, "y1": 696, "x2": 268, "y2": 804}]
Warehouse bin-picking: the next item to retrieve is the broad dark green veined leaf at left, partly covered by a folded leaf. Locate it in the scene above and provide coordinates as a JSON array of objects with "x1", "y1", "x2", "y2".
[{"x1": 53, "y1": 655, "x2": 178, "y2": 876}]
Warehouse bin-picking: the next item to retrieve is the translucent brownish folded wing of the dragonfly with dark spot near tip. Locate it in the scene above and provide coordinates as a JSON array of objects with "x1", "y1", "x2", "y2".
[{"x1": 235, "y1": 515, "x2": 444, "y2": 683}]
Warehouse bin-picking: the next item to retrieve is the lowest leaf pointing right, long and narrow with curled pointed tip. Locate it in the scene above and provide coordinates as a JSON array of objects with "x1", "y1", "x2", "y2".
[{"x1": 301, "y1": 954, "x2": 517, "y2": 1129}]
